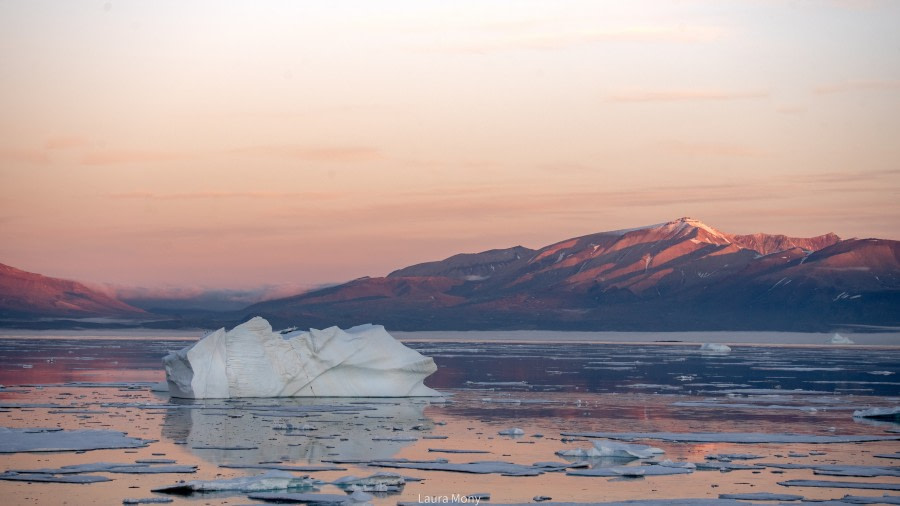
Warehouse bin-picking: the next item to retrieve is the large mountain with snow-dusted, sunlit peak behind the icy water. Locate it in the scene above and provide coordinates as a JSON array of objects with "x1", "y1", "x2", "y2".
[{"x1": 244, "y1": 218, "x2": 900, "y2": 331}]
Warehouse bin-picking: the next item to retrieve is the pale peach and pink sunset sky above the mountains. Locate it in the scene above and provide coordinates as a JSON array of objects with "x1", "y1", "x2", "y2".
[{"x1": 0, "y1": 0, "x2": 900, "y2": 294}]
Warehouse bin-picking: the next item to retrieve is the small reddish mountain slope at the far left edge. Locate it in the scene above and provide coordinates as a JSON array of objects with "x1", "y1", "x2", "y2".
[{"x1": 0, "y1": 264, "x2": 148, "y2": 320}]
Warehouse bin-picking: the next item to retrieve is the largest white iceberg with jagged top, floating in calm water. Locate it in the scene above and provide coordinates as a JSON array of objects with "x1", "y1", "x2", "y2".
[{"x1": 163, "y1": 317, "x2": 441, "y2": 399}]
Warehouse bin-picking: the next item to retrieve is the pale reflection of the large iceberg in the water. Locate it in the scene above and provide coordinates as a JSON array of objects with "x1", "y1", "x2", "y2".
[{"x1": 162, "y1": 398, "x2": 433, "y2": 464}]
